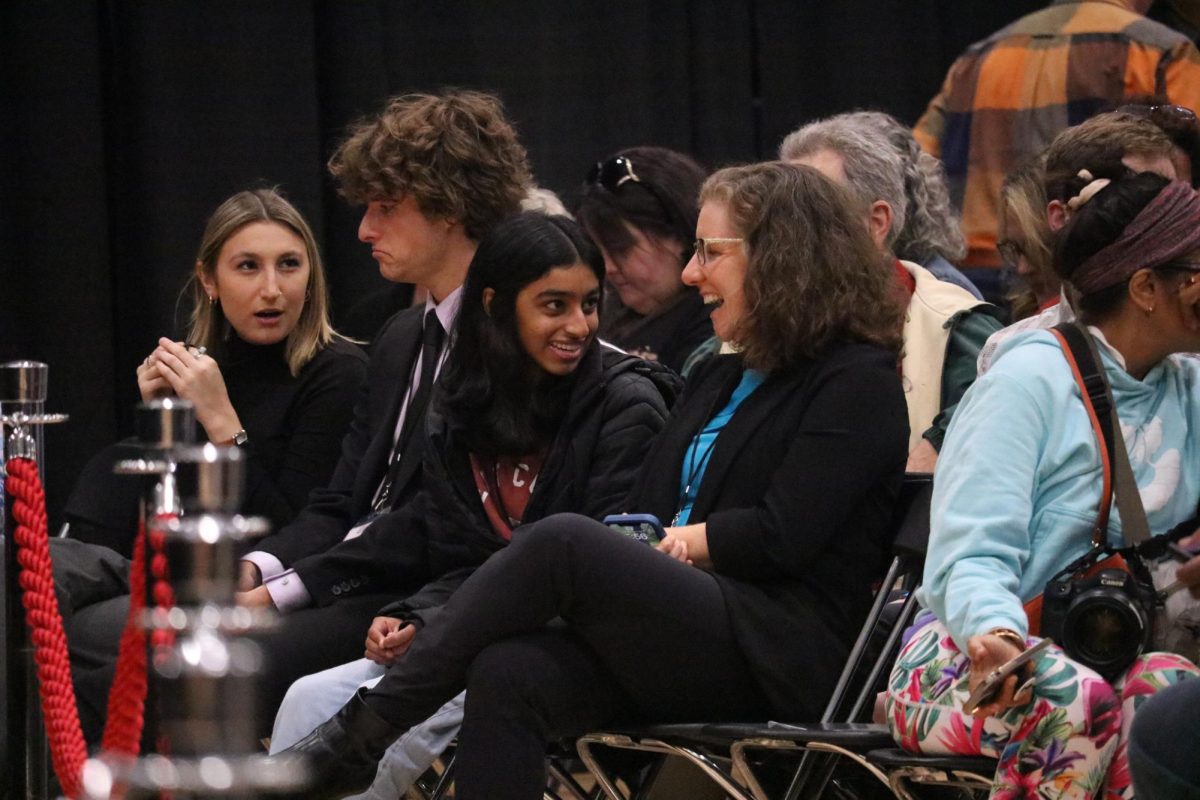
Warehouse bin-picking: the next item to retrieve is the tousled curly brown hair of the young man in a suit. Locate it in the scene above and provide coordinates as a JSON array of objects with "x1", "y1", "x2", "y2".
[{"x1": 329, "y1": 89, "x2": 533, "y2": 241}]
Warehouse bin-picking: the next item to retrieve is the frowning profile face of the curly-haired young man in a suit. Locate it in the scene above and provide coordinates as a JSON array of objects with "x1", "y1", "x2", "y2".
[{"x1": 359, "y1": 197, "x2": 454, "y2": 288}]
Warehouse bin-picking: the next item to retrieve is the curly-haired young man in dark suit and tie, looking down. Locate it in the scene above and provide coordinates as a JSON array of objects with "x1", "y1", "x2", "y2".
[{"x1": 239, "y1": 90, "x2": 532, "y2": 734}]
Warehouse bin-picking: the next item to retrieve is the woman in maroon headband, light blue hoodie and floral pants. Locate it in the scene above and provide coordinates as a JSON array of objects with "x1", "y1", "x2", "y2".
[{"x1": 887, "y1": 173, "x2": 1200, "y2": 798}]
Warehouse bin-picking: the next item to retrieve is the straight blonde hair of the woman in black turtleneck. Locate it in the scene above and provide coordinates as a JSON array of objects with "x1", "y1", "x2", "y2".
[{"x1": 185, "y1": 188, "x2": 338, "y2": 375}]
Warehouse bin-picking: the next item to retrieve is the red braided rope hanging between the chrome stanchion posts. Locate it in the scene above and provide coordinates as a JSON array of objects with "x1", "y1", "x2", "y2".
[{"x1": 5, "y1": 458, "x2": 175, "y2": 798}]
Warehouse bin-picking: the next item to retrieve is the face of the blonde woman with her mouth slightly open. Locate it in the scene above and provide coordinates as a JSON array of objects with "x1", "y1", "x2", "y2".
[{"x1": 200, "y1": 222, "x2": 311, "y2": 344}]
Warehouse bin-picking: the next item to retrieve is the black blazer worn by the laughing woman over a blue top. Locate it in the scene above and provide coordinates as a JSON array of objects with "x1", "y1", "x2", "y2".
[{"x1": 626, "y1": 344, "x2": 908, "y2": 720}]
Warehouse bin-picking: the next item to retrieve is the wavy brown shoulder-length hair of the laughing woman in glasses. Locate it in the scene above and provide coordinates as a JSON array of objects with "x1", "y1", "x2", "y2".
[{"x1": 700, "y1": 162, "x2": 904, "y2": 371}]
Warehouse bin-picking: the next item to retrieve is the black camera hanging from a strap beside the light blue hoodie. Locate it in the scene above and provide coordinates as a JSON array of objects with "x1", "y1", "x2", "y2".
[{"x1": 1042, "y1": 565, "x2": 1157, "y2": 681}]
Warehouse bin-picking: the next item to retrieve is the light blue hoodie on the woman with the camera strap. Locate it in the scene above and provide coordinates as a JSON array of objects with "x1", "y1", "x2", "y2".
[{"x1": 918, "y1": 331, "x2": 1200, "y2": 649}]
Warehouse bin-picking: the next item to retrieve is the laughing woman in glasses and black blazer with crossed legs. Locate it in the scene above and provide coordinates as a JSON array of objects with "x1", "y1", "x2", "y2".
[{"x1": 288, "y1": 163, "x2": 907, "y2": 800}]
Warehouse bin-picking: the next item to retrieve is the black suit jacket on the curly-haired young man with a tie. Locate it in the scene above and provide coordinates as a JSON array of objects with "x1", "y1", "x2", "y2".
[{"x1": 253, "y1": 306, "x2": 426, "y2": 567}]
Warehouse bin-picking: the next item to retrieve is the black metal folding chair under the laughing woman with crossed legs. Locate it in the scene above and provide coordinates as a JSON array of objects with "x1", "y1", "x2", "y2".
[{"x1": 576, "y1": 475, "x2": 932, "y2": 800}]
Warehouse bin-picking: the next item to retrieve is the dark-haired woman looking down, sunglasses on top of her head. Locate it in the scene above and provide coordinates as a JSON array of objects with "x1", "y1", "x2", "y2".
[{"x1": 577, "y1": 148, "x2": 713, "y2": 372}]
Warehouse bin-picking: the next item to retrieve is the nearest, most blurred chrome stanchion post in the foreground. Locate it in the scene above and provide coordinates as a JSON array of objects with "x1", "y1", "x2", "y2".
[{"x1": 85, "y1": 445, "x2": 307, "y2": 798}]
